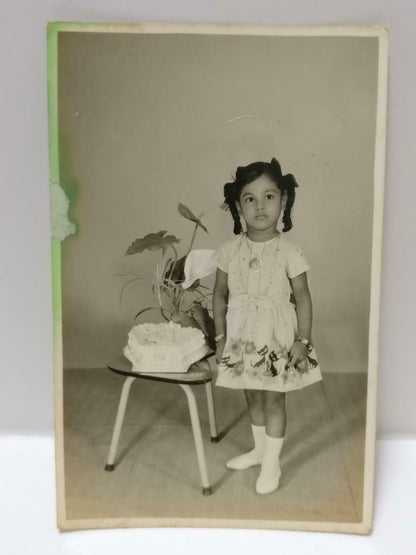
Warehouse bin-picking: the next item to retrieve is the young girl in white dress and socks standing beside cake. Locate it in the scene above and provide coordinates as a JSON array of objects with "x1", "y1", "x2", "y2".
[{"x1": 213, "y1": 158, "x2": 322, "y2": 494}]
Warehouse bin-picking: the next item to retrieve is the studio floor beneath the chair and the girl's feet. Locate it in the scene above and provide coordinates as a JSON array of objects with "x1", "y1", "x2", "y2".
[{"x1": 64, "y1": 369, "x2": 367, "y2": 522}]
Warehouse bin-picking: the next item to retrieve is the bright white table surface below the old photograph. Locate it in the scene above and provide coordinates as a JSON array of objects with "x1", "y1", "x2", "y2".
[{"x1": 0, "y1": 436, "x2": 416, "y2": 555}]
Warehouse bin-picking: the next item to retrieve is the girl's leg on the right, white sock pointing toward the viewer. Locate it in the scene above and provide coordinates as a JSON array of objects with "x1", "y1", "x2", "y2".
[{"x1": 256, "y1": 391, "x2": 287, "y2": 493}]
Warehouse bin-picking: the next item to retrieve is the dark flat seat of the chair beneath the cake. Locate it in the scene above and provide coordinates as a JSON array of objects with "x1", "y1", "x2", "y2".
[{"x1": 107, "y1": 352, "x2": 214, "y2": 385}]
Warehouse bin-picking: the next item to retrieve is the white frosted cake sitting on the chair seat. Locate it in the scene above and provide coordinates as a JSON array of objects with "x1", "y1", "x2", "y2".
[{"x1": 123, "y1": 322, "x2": 210, "y2": 373}]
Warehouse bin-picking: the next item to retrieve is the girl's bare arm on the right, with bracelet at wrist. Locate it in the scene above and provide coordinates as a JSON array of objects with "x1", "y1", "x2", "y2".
[{"x1": 290, "y1": 272, "x2": 312, "y2": 365}]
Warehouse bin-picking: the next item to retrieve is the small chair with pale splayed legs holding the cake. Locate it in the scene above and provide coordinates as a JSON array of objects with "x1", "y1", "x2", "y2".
[{"x1": 105, "y1": 353, "x2": 219, "y2": 495}]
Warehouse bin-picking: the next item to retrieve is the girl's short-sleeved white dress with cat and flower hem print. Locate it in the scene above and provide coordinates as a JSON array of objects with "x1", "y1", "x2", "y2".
[{"x1": 216, "y1": 233, "x2": 322, "y2": 392}]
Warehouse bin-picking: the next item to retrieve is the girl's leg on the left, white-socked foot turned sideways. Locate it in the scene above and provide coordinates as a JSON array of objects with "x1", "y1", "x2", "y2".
[{"x1": 227, "y1": 389, "x2": 266, "y2": 470}]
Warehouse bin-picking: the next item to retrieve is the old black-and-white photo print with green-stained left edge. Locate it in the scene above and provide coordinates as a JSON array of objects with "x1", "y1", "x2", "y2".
[{"x1": 48, "y1": 23, "x2": 388, "y2": 534}]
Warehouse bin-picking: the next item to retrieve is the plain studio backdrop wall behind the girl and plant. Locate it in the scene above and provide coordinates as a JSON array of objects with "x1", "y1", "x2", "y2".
[{"x1": 58, "y1": 32, "x2": 378, "y2": 372}]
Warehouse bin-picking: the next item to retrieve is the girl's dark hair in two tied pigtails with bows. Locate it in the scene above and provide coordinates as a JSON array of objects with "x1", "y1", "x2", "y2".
[{"x1": 224, "y1": 158, "x2": 298, "y2": 235}]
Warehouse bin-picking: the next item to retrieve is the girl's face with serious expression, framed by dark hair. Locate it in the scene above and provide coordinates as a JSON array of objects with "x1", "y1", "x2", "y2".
[{"x1": 239, "y1": 175, "x2": 282, "y2": 231}]
